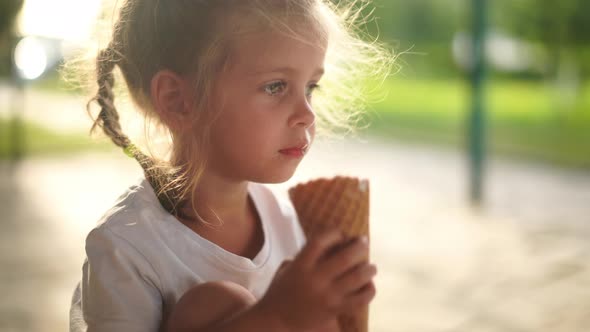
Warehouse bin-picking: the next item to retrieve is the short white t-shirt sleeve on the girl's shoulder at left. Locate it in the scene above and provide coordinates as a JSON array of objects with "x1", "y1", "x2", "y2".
[{"x1": 81, "y1": 227, "x2": 162, "y2": 332}]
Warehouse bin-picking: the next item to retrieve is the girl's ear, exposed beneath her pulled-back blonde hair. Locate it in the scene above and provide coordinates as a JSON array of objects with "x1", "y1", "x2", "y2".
[{"x1": 150, "y1": 70, "x2": 191, "y2": 131}]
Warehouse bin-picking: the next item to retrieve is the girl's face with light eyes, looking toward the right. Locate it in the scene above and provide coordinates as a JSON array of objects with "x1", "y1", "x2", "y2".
[{"x1": 208, "y1": 31, "x2": 326, "y2": 183}]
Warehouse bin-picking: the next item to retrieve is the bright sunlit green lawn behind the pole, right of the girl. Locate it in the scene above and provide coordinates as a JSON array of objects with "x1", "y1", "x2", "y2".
[{"x1": 367, "y1": 79, "x2": 590, "y2": 169}]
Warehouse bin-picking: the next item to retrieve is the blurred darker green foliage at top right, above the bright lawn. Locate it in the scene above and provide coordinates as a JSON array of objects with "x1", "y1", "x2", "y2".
[{"x1": 358, "y1": 0, "x2": 590, "y2": 78}]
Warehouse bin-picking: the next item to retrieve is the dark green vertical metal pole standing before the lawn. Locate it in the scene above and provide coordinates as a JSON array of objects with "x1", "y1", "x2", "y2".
[{"x1": 468, "y1": 0, "x2": 486, "y2": 206}]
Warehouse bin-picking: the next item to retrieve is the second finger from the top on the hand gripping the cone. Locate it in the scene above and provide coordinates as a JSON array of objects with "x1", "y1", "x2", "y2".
[{"x1": 319, "y1": 238, "x2": 369, "y2": 279}]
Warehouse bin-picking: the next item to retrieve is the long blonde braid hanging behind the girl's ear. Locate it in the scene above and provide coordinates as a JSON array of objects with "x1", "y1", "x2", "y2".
[{"x1": 88, "y1": 45, "x2": 184, "y2": 217}]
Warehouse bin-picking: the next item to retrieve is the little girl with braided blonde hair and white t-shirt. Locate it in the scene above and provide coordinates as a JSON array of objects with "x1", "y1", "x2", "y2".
[{"x1": 70, "y1": 0, "x2": 392, "y2": 332}]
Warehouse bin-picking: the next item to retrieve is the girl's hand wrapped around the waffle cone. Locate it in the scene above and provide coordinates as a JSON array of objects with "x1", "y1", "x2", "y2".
[{"x1": 257, "y1": 230, "x2": 377, "y2": 331}]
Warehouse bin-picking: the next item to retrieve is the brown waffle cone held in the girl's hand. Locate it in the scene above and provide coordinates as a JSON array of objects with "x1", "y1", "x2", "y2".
[{"x1": 289, "y1": 176, "x2": 369, "y2": 332}]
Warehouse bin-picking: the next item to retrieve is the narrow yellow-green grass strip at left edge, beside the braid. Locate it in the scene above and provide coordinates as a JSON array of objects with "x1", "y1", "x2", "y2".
[{"x1": 0, "y1": 118, "x2": 113, "y2": 160}]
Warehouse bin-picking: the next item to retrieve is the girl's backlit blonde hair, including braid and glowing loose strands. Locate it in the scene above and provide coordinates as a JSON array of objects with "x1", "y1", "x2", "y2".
[{"x1": 75, "y1": 0, "x2": 395, "y2": 223}]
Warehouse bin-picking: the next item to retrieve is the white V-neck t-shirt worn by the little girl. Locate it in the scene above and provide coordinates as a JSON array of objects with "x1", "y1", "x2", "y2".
[{"x1": 70, "y1": 178, "x2": 305, "y2": 332}]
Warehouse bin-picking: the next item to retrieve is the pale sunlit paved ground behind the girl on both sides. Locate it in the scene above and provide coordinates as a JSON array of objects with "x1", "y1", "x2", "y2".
[{"x1": 0, "y1": 136, "x2": 590, "y2": 332}]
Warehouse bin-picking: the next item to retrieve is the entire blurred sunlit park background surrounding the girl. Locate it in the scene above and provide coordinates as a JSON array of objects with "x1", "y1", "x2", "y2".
[{"x1": 0, "y1": 0, "x2": 590, "y2": 332}]
